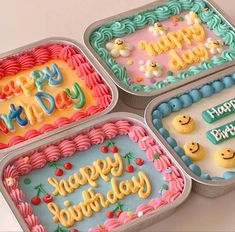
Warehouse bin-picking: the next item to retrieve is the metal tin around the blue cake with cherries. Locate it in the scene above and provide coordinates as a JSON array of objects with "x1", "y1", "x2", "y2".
[{"x1": 0, "y1": 112, "x2": 192, "y2": 232}]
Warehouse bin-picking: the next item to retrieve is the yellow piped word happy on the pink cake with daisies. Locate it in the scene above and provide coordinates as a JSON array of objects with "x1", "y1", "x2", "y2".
[{"x1": 138, "y1": 23, "x2": 206, "y2": 56}]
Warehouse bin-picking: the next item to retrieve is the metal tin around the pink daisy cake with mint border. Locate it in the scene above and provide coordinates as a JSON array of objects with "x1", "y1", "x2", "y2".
[{"x1": 83, "y1": 0, "x2": 235, "y2": 109}]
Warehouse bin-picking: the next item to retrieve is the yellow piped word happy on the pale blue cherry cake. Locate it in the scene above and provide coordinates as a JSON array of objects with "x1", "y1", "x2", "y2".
[{"x1": 48, "y1": 153, "x2": 123, "y2": 196}]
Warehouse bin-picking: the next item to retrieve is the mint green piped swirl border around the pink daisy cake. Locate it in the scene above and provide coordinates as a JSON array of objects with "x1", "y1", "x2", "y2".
[{"x1": 89, "y1": 0, "x2": 235, "y2": 91}]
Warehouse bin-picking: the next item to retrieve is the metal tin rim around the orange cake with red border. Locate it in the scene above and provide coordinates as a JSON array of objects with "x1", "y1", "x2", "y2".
[{"x1": 0, "y1": 37, "x2": 118, "y2": 154}]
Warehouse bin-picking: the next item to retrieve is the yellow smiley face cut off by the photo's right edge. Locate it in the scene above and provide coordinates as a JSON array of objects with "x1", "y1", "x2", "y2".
[{"x1": 215, "y1": 148, "x2": 235, "y2": 168}]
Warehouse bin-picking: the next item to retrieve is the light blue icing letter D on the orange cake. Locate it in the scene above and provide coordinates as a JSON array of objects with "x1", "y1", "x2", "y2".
[{"x1": 35, "y1": 91, "x2": 55, "y2": 114}]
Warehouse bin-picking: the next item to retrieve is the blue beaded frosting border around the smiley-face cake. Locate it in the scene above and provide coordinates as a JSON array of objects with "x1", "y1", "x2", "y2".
[{"x1": 152, "y1": 73, "x2": 235, "y2": 180}]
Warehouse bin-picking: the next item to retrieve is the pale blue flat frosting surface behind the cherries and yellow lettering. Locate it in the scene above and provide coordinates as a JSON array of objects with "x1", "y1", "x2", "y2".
[{"x1": 19, "y1": 136, "x2": 167, "y2": 231}]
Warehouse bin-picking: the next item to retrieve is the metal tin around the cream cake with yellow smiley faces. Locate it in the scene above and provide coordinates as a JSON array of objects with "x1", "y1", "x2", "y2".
[{"x1": 144, "y1": 61, "x2": 235, "y2": 197}]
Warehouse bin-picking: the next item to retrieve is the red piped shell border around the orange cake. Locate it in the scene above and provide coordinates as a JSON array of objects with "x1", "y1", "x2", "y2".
[{"x1": 0, "y1": 43, "x2": 112, "y2": 149}]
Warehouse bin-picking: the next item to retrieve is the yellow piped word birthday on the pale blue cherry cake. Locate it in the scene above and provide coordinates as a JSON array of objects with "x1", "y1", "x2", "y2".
[{"x1": 47, "y1": 171, "x2": 152, "y2": 227}]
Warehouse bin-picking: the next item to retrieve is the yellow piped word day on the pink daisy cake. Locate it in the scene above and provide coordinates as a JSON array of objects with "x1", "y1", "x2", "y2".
[{"x1": 169, "y1": 44, "x2": 209, "y2": 70}]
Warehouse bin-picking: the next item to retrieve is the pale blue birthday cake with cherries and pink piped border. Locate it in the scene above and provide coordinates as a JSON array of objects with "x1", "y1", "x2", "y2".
[{"x1": 3, "y1": 120, "x2": 185, "y2": 232}]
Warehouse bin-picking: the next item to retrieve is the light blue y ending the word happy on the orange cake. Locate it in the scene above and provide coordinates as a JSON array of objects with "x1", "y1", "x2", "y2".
[{"x1": 43, "y1": 64, "x2": 63, "y2": 86}]
